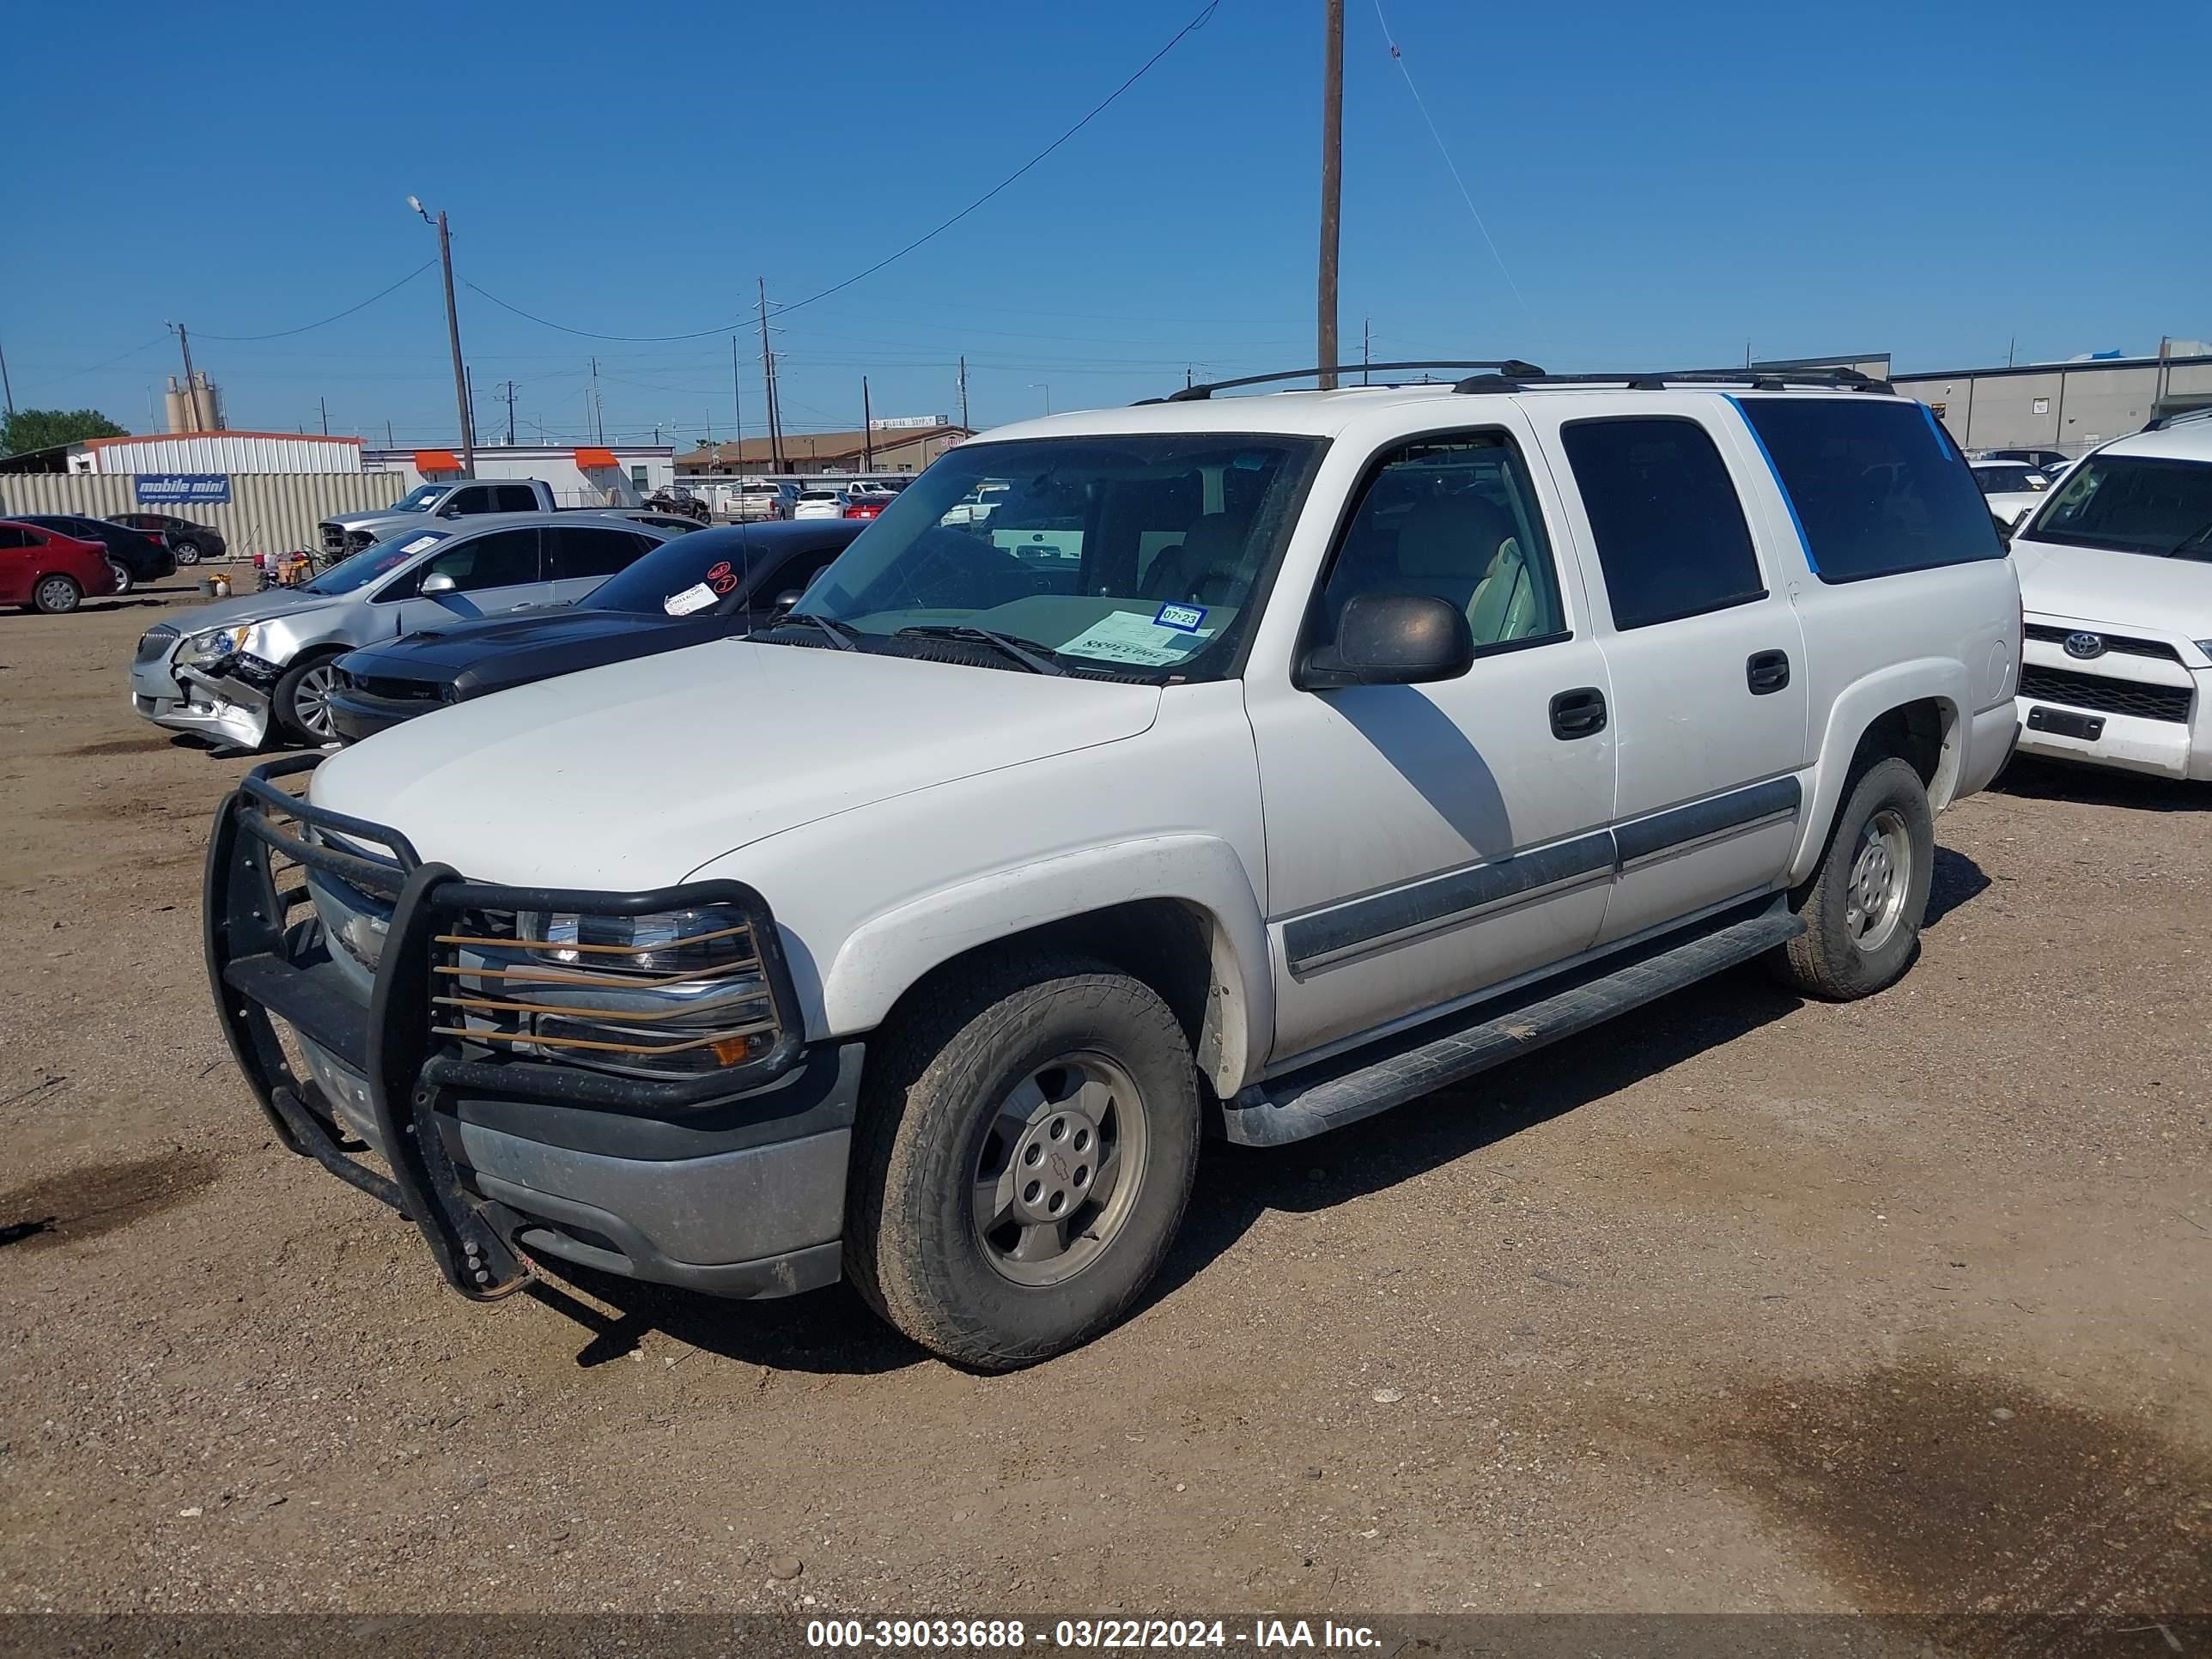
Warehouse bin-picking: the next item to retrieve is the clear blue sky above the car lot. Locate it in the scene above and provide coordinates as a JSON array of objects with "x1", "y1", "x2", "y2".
[{"x1": 0, "y1": 0, "x2": 2212, "y2": 442}]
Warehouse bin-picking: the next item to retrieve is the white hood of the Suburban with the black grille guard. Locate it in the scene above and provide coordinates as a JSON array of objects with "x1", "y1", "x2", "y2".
[{"x1": 312, "y1": 639, "x2": 1159, "y2": 890}]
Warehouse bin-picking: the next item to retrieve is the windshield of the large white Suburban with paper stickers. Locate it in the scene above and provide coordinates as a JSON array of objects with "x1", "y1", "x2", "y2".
[{"x1": 796, "y1": 434, "x2": 1325, "y2": 679}]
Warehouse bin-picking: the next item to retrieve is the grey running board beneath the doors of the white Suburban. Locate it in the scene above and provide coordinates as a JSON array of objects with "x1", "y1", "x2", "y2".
[{"x1": 1224, "y1": 896, "x2": 1805, "y2": 1146}]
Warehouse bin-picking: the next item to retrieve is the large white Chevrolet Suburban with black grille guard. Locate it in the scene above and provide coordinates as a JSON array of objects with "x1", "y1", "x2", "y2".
[{"x1": 206, "y1": 362, "x2": 2020, "y2": 1367}]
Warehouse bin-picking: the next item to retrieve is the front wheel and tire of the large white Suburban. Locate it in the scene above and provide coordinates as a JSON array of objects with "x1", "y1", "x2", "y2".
[{"x1": 845, "y1": 956, "x2": 1199, "y2": 1371}]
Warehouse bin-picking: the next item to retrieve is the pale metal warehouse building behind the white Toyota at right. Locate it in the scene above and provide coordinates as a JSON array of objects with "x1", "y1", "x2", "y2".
[{"x1": 1889, "y1": 356, "x2": 2212, "y2": 456}]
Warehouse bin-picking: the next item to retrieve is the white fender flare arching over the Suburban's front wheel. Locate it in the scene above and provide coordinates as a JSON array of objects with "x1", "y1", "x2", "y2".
[{"x1": 821, "y1": 834, "x2": 1274, "y2": 1099}]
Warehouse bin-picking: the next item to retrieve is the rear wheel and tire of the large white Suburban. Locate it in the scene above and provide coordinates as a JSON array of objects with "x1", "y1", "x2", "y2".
[{"x1": 1771, "y1": 757, "x2": 1936, "y2": 1002}]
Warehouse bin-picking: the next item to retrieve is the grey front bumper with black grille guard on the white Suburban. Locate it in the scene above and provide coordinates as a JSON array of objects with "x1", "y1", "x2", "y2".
[{"x1": 206, "y1": 757, "x2": 845, "y2": 1301}]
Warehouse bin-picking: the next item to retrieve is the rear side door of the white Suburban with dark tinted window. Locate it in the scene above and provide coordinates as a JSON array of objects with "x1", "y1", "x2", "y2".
[{"x1": 1526, "y1": 392, "x2": 1808, "y2": 945}]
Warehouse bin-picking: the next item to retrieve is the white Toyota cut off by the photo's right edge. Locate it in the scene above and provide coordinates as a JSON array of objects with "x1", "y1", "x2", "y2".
[{"x1": 2013, "y1": 420, "x2": 2212, "y2": 781}]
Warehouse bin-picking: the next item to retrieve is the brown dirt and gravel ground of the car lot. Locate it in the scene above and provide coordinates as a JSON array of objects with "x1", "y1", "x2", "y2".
[{"x1": 0, "y1": 584, "x2": 2212, "y2": 1617}]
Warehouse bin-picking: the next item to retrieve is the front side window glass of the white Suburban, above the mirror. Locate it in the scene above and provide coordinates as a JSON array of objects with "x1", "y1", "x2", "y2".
[{"x1": 1321, "y1": 435, "x2": 1566, "y2": 650}]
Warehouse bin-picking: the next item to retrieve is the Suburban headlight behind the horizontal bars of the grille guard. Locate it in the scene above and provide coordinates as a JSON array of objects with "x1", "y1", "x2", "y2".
[{"x1": 434, "y1": 905, "x2": 783, "y2": 1078}]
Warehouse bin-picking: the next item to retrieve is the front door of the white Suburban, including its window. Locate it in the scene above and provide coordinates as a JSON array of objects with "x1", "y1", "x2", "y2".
[{"x1": 1245, "y1": 416, "x2": 1613, "y2": 1066}]
